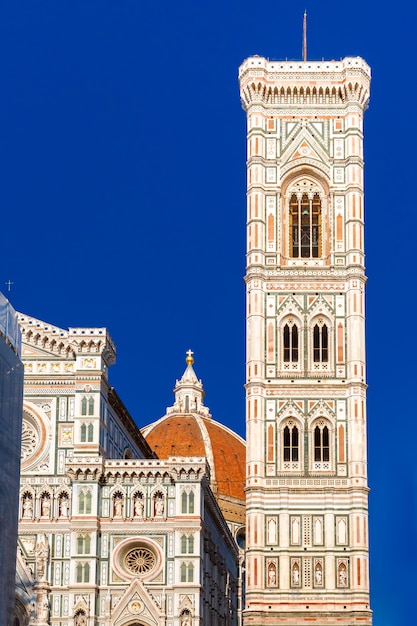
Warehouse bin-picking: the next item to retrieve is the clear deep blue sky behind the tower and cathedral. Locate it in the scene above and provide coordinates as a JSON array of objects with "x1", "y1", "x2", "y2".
[{"x1": 0, "y1": 0, "x2": 417, "y2": 626}]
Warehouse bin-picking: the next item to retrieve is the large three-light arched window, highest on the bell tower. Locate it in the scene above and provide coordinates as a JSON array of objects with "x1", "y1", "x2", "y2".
[{"x1": 289, "y1": 193, "x2": 322, "y2": 259}]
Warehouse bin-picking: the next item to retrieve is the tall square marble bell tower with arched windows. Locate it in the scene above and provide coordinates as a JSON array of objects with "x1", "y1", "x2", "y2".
[{"x1": 239, "y1": 56, "x2": 372, "y2": 626}]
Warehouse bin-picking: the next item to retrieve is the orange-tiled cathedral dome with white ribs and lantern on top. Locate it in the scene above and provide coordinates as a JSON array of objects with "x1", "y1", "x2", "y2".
[{"x1": 142, "y1": 351, "x2": 246, "y2": 523}]
